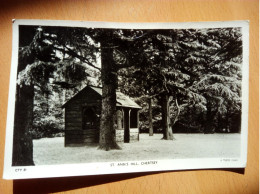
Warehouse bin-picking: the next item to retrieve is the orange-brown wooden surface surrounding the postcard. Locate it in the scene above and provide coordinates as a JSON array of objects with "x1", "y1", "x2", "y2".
[{"x1": 0, "y1": 0, "x2": 259, "y2": 194}]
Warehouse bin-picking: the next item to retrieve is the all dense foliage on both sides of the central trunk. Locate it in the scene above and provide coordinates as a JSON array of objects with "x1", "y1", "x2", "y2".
[{"x1": 19, "y1": 28, "x2": 242, "y2": 137}]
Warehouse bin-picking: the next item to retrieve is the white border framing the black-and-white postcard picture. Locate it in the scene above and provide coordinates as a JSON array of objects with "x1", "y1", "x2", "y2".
[{"x1": 3, "y1": 20, "x2": 249, "y2": 179}]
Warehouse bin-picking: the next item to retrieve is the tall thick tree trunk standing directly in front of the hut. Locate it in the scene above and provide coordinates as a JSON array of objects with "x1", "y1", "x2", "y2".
[{"x1": 99, "y1": 44, "x2": 120, "y2": 151}]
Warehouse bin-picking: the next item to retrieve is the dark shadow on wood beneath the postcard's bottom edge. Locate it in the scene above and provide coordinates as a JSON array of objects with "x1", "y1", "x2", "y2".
[{"x1": 13, "y1": 168, "x2": 245, "y2": 194}]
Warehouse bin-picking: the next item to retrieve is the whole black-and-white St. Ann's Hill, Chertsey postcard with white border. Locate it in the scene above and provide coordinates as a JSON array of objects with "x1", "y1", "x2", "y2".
[{"x1": 3, "y1": 20, "x2": 249, "y2": 179}]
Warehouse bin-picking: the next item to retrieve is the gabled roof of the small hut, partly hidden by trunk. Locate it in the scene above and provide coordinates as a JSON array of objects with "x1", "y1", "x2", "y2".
[{"x1": 62, "y1": 86, "x2": 142, "y2": 109}]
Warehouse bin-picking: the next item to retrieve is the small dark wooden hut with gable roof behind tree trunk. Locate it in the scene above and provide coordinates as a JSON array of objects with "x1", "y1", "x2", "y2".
[{"x1": 62, "y1": 86, "x2": 141, "y2": 146}]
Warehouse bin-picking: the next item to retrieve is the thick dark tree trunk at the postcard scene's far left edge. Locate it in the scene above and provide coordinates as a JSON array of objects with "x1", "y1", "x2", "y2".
[{"x1": 12, "y1": 85, "x2": 34, "y2": 166}]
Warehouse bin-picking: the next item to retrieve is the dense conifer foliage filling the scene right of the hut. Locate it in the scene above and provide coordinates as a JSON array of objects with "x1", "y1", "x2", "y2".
[{"x1": 118, "y1": 28, "x2": 242, "y2": 133}]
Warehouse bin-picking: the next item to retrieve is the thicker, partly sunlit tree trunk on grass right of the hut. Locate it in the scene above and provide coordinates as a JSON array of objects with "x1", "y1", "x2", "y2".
[{"x1": 161, "y1": 94, "x2": 173, "y2": 140}]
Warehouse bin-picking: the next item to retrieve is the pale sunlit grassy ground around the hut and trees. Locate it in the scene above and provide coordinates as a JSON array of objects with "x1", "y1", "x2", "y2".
[{"x1": 33, "y1": 134, "x2": 240, "y2": 165}]
